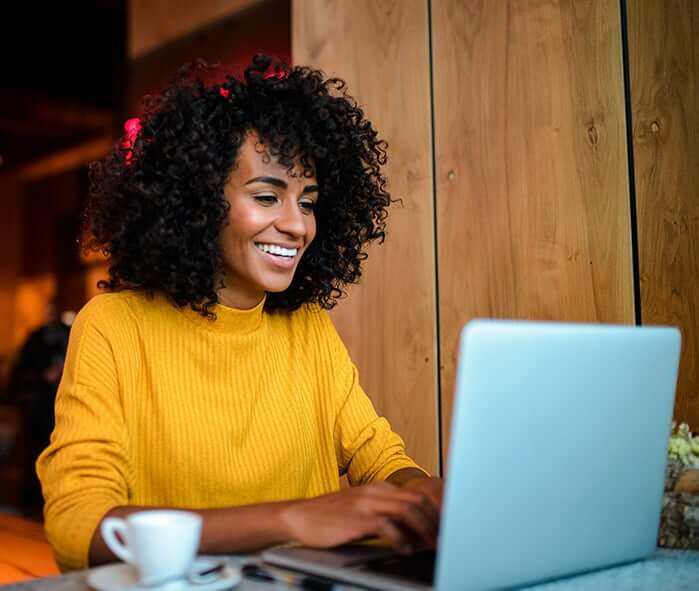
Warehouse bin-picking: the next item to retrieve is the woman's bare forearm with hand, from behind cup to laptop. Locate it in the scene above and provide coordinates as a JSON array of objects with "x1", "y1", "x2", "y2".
[{"x1": 89, "y1": 480, "x2": 441, "y2": 566}]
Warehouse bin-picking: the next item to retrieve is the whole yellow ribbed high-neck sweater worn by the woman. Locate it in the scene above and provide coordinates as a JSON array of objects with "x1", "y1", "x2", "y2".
[{"x1": 37, "y1": 291, "x2": 426, "y2": 569}]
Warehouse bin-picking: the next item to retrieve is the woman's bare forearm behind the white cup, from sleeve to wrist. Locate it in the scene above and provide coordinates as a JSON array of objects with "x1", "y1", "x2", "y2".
[{"x1": 89, "y1": 501, "x2": 295, "y2": 566}]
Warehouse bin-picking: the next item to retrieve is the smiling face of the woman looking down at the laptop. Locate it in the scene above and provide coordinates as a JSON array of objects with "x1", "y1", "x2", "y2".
[{"x1": 218, "y1": 133, "x2": 318, "y2": 308}]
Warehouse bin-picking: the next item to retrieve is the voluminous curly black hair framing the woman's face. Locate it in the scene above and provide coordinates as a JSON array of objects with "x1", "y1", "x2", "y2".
[{"x1": 83, "y1": 55, "x2": 392, "y2": 318}]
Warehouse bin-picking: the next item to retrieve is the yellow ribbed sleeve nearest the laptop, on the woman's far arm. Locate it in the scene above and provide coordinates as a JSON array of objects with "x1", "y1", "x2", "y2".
[{"x1": 319, "y1": 312, "x2": 427, "y2": 485}]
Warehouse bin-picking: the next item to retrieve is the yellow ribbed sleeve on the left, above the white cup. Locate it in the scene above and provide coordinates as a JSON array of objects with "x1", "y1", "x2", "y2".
[{"x1": 37, "y1": 296, "x2": 129, "y2": 570}]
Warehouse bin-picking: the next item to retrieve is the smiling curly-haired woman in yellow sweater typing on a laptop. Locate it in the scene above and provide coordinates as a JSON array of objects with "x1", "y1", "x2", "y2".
[{"x1": 38, "y1": 56, "x2": 441, "y2": 569}]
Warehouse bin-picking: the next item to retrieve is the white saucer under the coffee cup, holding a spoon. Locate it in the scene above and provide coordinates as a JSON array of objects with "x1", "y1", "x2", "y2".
[{"x1": 87, "y1": 558, "x2": 241, "y2": 591}]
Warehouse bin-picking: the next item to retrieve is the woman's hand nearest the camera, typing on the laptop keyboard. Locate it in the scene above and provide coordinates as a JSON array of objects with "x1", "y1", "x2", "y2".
[{"x1": 281, "y1": 478, "x2": 441, "y2": 552}]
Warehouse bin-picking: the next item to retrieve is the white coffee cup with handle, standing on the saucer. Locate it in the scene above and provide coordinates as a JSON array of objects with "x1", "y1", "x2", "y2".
[{"x1": 100, "y1": 509, "x2": 202, "y2": 585}]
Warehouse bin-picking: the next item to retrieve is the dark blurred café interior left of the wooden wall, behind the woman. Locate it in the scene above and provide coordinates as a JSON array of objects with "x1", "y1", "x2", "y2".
[{"x1": 0, "y1": 0, "x2": 291, "y2": 517}]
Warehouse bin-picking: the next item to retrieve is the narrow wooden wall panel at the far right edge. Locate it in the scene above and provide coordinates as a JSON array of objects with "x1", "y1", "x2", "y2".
[{"x1": 628, "y1": 0, "x2": 699, "y2": 431}]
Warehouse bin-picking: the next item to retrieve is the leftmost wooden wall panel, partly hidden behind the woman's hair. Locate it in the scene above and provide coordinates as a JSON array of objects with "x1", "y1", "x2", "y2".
[{"x1": 292, "y1": 0, "x2": 439, "y2": 473}]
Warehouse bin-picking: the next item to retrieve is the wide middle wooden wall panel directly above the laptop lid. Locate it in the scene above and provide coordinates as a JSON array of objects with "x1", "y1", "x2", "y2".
[{"x1": 431, "y1": 0, "x2": 634, "y2": 460}]
